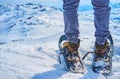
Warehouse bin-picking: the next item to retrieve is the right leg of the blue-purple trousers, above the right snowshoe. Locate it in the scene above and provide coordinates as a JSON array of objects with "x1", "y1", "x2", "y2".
[{"x1": 92, "y1": 0, "x2": 110, "y2": 45}]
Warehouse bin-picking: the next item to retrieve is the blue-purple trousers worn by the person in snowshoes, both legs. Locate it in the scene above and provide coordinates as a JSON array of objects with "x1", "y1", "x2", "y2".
[{"x1": 63, "y1": 0, "x2": 111, "y2": 45}]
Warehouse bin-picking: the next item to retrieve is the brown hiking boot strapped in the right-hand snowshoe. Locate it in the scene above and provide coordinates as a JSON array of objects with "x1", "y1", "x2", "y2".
[{"x1": 95, "y1": 41, "x2": 109, "y2": 58}]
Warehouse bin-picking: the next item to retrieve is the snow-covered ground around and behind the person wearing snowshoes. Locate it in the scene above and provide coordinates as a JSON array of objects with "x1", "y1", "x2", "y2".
[{"x1": 0, "y1": 3, "x2": 120, "y2": 79}]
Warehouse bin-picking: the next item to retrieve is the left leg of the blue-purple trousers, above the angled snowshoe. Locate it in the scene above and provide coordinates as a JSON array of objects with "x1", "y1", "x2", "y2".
[{"x1": 63, "y1": 0, "x2": 80, "y2": 43}]
